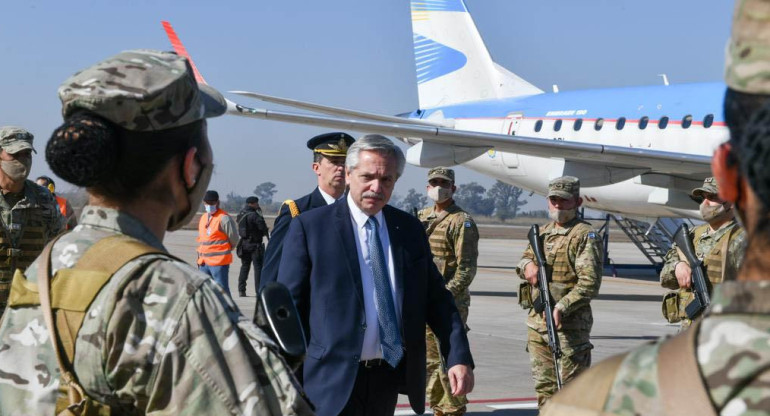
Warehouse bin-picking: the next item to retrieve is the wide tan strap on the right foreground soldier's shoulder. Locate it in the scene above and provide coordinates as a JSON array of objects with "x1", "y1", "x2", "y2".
[{"x1": 658, "y1": 320, "x2": 717, "y2": 416}]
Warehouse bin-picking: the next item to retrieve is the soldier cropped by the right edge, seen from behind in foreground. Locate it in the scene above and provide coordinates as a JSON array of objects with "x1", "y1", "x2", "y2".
[{"x1": 541, "y1": 0, "x2": 770, "y2": 416}]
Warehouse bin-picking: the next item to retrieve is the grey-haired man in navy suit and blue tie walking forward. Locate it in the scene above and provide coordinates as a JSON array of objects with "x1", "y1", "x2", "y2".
[{"x1": 278, "y1": 135, "x2": 473, "y2": 416}]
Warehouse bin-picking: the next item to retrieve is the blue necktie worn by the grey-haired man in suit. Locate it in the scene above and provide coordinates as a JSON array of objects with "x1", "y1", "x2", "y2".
[{"x1": 366, "y1": 217, "x2": 404, "y2": 368}]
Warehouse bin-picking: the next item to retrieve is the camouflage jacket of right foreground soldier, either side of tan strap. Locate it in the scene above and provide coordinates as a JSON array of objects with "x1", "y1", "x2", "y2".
[{"x1": 584, "y1": 280, "x2": 770, "y2": 415}]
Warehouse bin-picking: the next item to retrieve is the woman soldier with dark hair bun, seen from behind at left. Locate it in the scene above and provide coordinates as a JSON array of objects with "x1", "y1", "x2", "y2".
[{"x1": 0, "y1": 50, "x2": 312, "y2": 415}]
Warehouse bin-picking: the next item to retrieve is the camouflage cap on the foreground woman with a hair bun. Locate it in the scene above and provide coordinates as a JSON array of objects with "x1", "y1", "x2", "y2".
[{"x1": 59, "y1": 50, "x2": 227, "y2": 131}]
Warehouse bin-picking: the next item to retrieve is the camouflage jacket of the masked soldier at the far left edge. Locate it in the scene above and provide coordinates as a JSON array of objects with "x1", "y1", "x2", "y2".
[{"x1": 0, "y1": 180, "x2": 64, "y2": 317}]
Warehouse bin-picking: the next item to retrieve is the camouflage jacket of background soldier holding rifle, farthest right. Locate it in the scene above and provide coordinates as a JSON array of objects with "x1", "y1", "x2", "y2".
[{"x1": 660, "y1": 219, "x2": 746, "y2": 290}]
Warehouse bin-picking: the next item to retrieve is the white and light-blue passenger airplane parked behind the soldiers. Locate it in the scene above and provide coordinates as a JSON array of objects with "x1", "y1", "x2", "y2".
[{"x1": 163, "y1": 0, "x2": 728, "y2": 221}]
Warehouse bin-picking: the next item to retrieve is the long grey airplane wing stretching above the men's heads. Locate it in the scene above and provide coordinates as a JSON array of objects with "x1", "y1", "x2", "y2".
[{"x1": 222, "y1": 91, "x2": 711, "y2": 177}]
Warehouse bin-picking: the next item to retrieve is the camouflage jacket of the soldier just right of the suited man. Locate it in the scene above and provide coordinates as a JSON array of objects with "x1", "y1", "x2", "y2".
[{"x1": 417, "y1": 203, "x2": 479, "y2": 308}]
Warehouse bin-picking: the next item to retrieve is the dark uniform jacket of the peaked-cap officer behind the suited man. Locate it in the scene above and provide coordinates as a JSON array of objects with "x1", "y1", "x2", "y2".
[{"x1": 259, "y1": 187, "x2": 327, "y2": 290}]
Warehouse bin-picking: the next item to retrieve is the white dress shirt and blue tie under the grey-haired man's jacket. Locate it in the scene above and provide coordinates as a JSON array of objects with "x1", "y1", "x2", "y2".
[{"x1": 347, "y1": 194, "x2": 403, "y2": 361}]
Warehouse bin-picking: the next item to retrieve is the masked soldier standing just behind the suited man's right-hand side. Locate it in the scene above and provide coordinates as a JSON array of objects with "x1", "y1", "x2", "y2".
[{"x1": 417, "y1": 167, "x2": 479, "y2": 416}]
